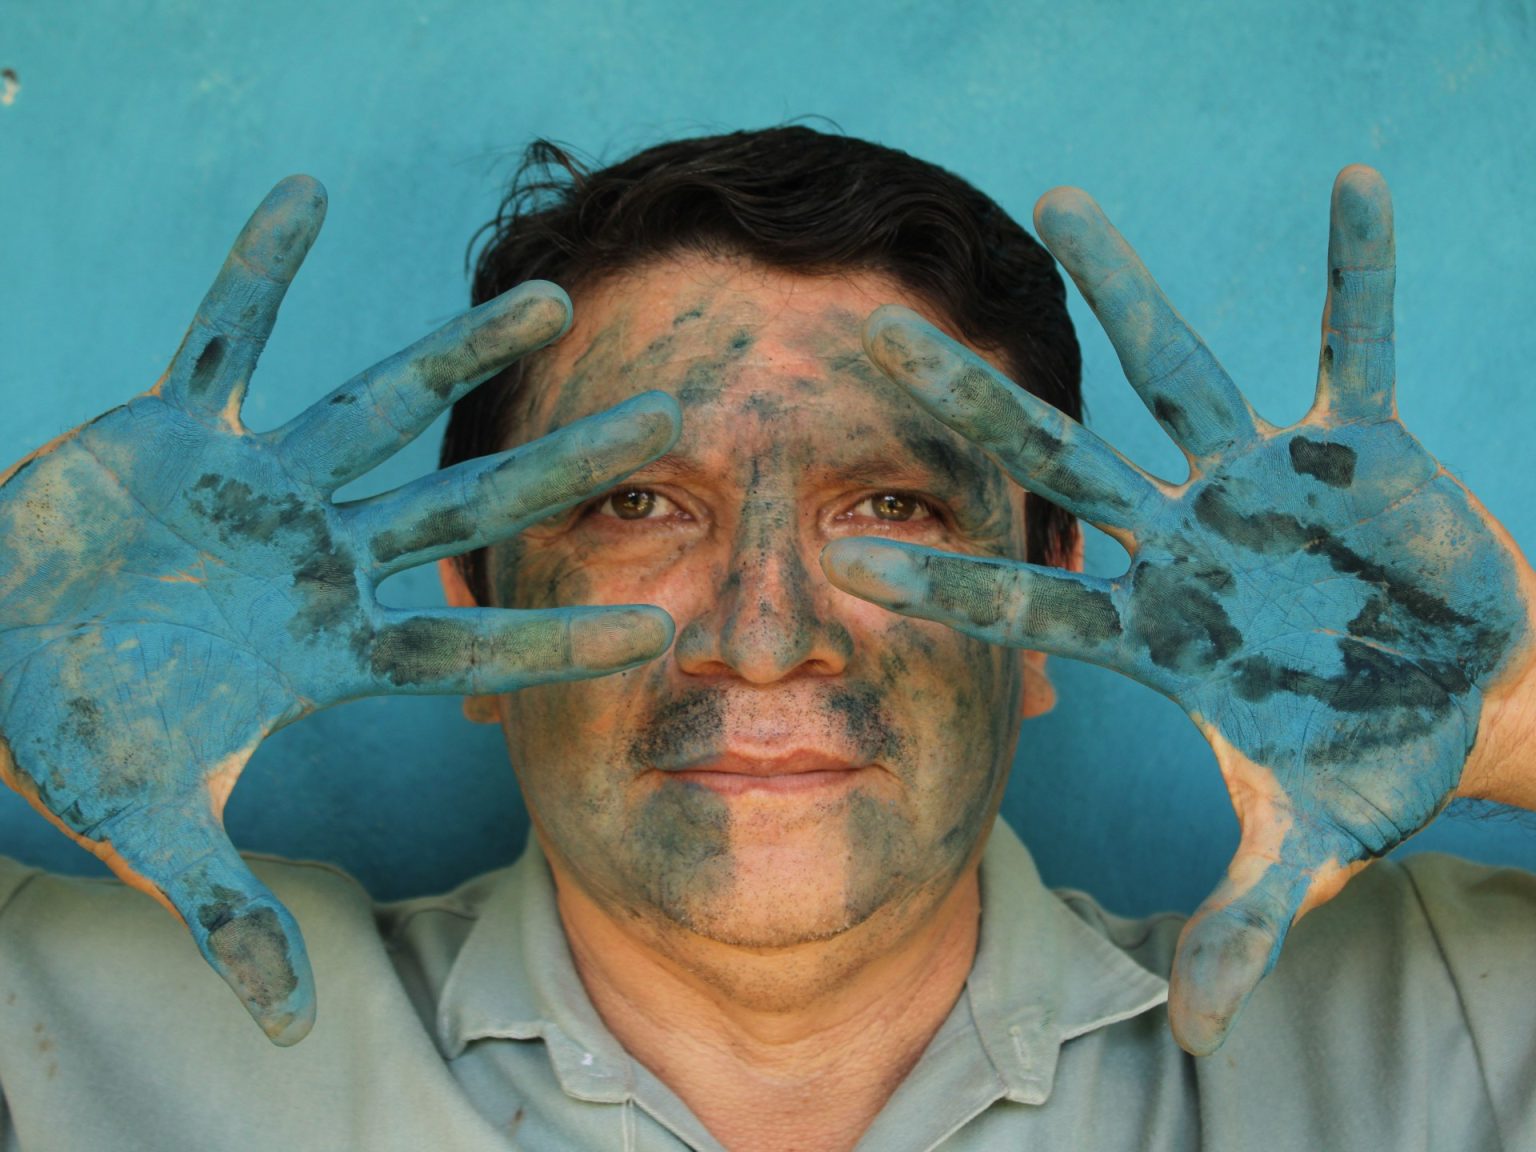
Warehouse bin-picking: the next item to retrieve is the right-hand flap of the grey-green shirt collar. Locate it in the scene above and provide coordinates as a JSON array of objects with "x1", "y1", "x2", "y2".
[{"x1": 968, "y1": 820, "x2": 1167, "y2": 1104}]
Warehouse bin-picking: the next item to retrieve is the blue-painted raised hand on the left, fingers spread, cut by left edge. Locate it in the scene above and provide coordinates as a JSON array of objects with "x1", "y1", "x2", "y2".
[{"x1": 0, "y1": 177, "x2": 679, "y2": 1044}]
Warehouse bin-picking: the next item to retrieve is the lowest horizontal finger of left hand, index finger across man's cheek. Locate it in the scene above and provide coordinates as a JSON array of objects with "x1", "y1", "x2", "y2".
[{"x1": 369, "y1": 605, "x2": 673, "y2": 696}]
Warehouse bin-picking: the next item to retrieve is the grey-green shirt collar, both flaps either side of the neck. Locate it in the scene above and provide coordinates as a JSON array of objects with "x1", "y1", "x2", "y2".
[{"x1": 436, "y1": 820, "x2": 1167, "y2": 1104}]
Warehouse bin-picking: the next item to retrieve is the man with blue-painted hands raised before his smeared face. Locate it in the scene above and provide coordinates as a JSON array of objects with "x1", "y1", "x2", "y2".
[{"x1": 0, "y1": 129, "x2": 1536, "y2": 1149}]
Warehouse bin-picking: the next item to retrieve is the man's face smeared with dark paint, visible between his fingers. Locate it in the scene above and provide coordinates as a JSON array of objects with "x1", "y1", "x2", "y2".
[{"x1": 490, "y1": 257, "x2": 1025, "y2": 948}]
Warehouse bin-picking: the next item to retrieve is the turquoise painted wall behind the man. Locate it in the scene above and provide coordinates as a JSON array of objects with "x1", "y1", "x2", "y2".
[{"x1": 0, "y1": 0, "x2": 1536, "y2": 912}]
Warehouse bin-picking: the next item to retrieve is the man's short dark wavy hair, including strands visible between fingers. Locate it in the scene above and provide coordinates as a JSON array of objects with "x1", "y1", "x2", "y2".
[{"x1": 439, "y1": 124, "x2": 1083, "y2": 604}]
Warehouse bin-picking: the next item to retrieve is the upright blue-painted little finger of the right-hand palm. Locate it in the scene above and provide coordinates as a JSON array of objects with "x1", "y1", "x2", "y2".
[{"x1": 1315, "y1": 164, "x2": 1398, "y2": 421}]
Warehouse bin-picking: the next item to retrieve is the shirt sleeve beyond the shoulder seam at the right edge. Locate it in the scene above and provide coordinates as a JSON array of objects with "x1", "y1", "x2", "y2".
[{"x1": 1401, "y1": 852, "x2": 1536, "y2": 1147}]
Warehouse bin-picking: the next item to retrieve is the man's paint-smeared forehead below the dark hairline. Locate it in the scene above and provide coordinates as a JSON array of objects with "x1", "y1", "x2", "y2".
[{"x1": 513, "y1": 261, "x2": 1021, "y2": 549}]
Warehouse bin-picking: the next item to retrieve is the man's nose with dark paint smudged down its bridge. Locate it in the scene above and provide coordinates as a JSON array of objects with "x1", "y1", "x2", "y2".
[{"x1": 677, "y1": 499, "x2": 852, "y2": 684}]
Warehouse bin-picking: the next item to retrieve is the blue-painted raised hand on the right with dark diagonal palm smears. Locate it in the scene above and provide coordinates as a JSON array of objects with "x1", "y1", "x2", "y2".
[{"x1": 823, "y1": 167, "x2": 1533, "y2": 1054}]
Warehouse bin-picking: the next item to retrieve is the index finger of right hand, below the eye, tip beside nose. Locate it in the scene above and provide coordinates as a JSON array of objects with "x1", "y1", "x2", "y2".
[{"x1": 822, "y1": 538, "x2": 1121, "y2": 667}]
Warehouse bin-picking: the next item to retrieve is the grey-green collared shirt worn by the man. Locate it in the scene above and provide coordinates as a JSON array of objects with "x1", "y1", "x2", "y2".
[{"x1": 0, "y1": 823, "x2": 1536, "y2": 1152}]
